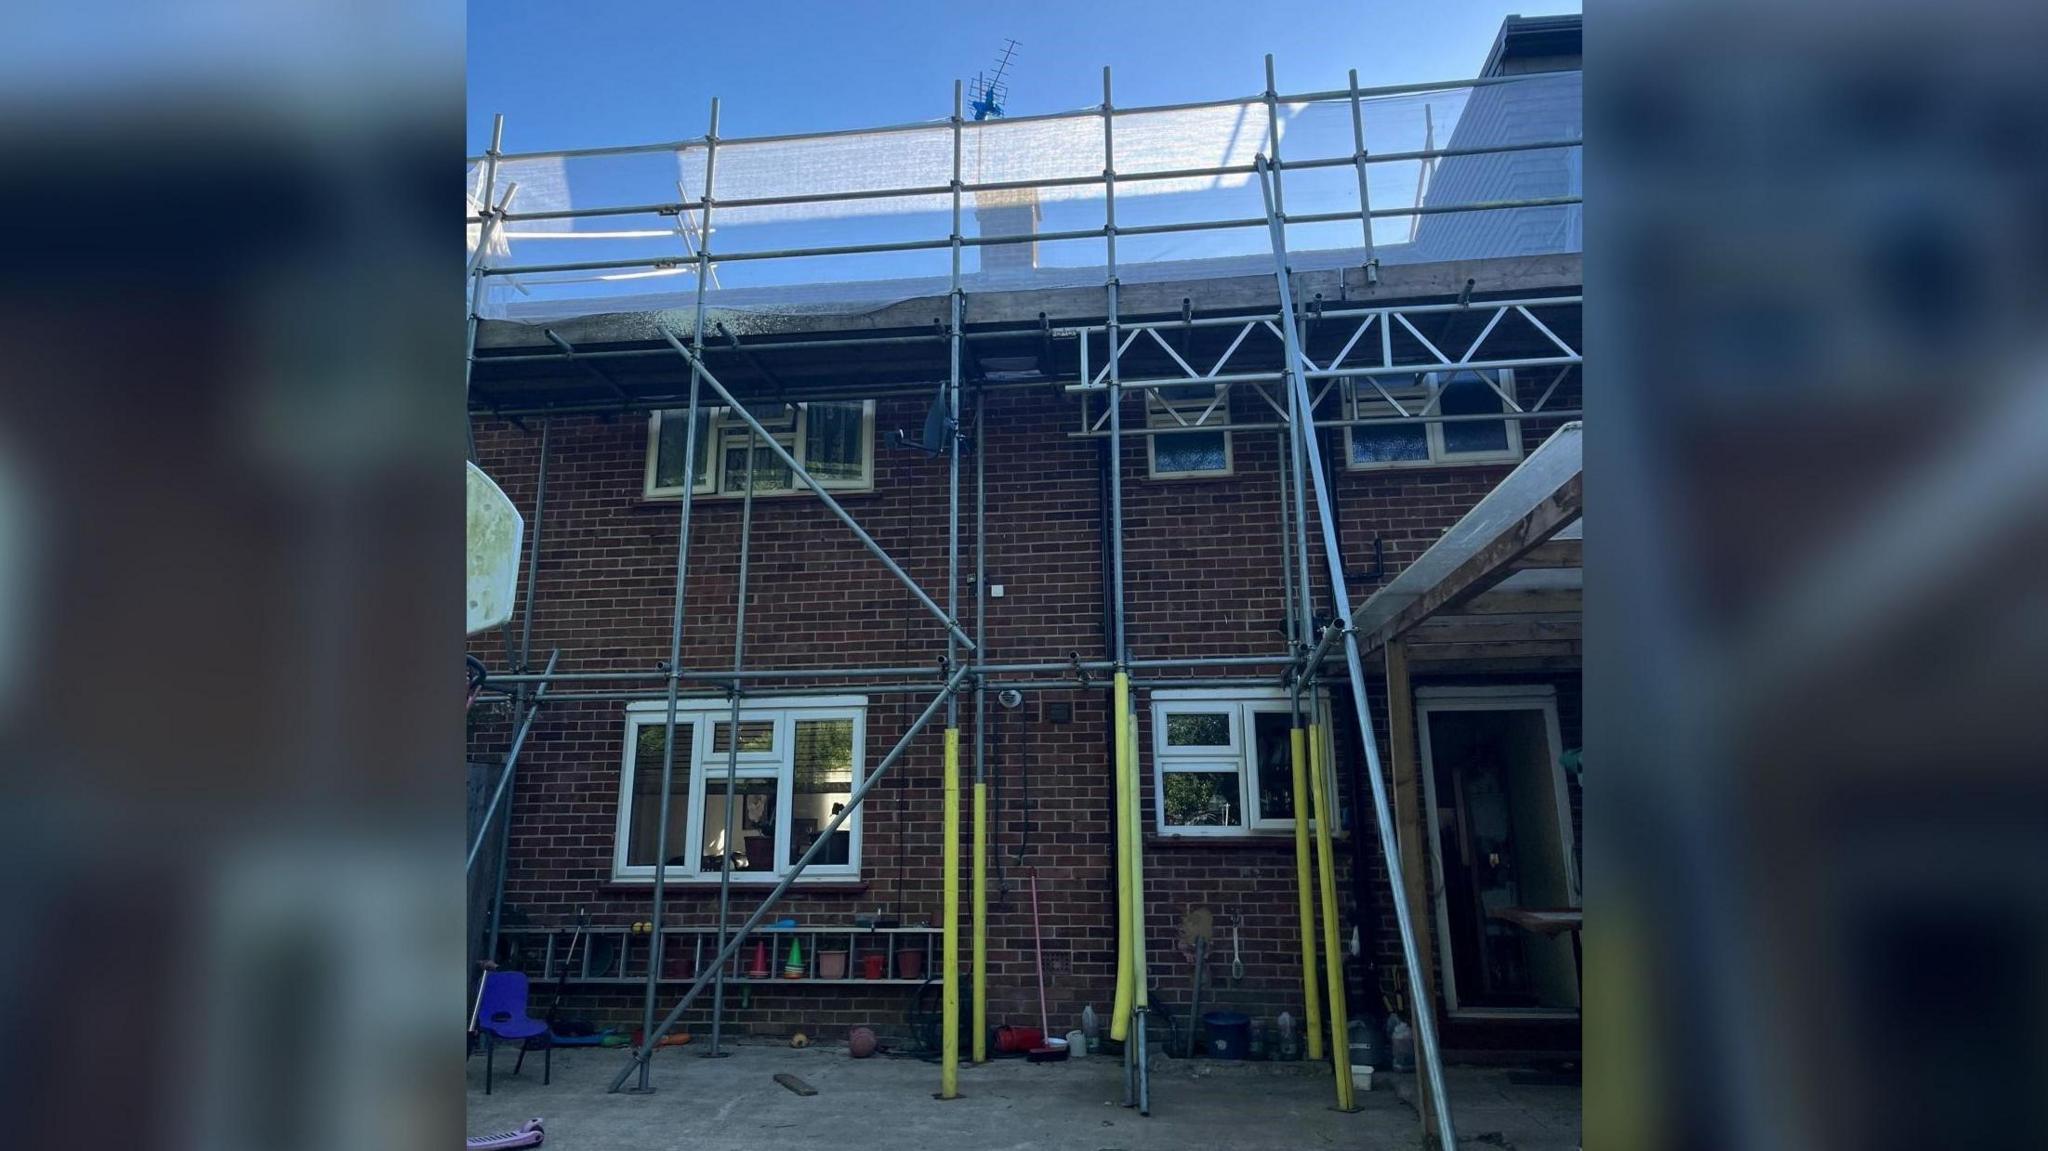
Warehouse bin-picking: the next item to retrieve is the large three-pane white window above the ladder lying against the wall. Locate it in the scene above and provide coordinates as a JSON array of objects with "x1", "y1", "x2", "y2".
[{"x1": 612, "y1": 696, "x2": 866, "y2": 883}]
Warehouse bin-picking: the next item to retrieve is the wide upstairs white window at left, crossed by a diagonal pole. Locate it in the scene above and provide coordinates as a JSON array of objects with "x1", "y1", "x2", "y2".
[{"x1": 645, "y1": 399, "x2": 874, "y2": 500}]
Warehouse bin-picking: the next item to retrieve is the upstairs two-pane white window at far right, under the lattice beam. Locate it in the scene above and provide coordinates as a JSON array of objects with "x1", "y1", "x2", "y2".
[{"x1": 1343, "y1": 369, "x2": 1522, "y2": 471}]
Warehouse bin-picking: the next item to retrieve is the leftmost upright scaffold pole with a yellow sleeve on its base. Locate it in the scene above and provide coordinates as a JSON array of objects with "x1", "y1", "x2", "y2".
[{"x1": 938, "y1": 80, "x2": 983, "y2": 1100}]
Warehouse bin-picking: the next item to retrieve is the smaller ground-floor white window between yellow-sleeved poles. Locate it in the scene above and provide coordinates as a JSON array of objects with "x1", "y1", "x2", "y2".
[{"x1": 1151, "y1": 688, "x2": 1335, "y2": 836}]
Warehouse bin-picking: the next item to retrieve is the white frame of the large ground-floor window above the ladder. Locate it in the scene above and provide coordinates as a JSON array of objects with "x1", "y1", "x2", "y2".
[{"x1": 612, "y1": 696, "x2": 868, "y2": 885}]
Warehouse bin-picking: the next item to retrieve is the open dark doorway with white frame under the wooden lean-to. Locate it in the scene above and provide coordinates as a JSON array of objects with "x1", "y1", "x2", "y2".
[{"x1": 1415, "y1": 686, "x2": 1579, "y2": 1016}]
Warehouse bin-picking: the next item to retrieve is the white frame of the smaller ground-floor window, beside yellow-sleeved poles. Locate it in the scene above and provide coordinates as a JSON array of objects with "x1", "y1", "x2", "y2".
[{"x1": 1149, "y1": 688, "x2": 1335, "y2": 838}]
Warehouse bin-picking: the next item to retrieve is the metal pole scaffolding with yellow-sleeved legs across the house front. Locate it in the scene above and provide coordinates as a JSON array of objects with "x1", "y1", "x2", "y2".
[{"x1": 465, "y1": 57, "x2": 1581, "y2": 1147}]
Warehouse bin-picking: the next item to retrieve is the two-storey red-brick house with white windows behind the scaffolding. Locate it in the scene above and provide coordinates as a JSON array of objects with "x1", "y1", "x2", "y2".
[{"x1": 471, "y1": 11, "x2": 1581, "y2": 1051}]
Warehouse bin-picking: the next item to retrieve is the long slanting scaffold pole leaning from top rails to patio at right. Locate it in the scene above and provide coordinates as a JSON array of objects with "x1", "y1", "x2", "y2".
[{"x1": 1253, "y1": 156, "x2": 1458, "y2": 1149}]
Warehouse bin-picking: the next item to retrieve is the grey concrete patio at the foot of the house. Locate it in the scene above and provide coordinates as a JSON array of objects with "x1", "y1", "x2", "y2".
[{"x1": 469, "y1": 1042, "x2": 1579, "y2": 1151}]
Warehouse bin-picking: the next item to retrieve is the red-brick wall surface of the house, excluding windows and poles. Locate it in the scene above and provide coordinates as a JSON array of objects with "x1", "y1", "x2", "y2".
[{"x1": 471, "y1": 374, "x2": 1577, "y2": 1032}]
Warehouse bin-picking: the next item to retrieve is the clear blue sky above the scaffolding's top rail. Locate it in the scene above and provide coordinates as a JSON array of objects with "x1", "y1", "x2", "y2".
[{"x1": 469, "y1": 0, "x2": 1579, "y2": 154}]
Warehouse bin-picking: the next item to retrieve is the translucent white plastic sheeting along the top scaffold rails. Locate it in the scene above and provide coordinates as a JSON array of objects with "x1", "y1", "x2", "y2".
[{"x1": 467, "y1": 74, "x2": 1579, "y2": 322}]
